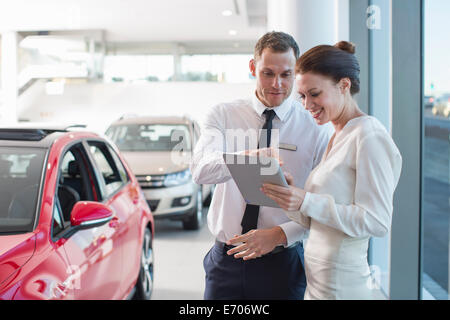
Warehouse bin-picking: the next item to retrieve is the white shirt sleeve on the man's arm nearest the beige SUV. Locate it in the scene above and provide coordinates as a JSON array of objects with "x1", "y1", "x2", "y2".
[{"x1": 190, "y1": 106, "x2": 231, "y2": 184}]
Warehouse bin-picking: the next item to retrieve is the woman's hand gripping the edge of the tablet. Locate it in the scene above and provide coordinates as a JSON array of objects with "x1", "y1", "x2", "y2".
[{"x1": 261, "y1": 181, "x2": 306, "y2": 211}]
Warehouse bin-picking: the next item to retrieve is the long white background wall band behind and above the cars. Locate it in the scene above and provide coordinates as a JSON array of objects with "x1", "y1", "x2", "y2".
[{"x1": 18, "y1": 82, "x2": 255, "y2": 132}]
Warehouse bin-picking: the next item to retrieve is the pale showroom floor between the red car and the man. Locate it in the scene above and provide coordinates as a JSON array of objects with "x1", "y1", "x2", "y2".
[{"x1": 152, "y1": 208, "x2": 214, "y2": 300}]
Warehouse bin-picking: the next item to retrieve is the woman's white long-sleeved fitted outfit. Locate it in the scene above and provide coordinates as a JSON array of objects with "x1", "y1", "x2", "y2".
[{"x1": 287, "y1": 116, "x2": 402, "y2": 299}]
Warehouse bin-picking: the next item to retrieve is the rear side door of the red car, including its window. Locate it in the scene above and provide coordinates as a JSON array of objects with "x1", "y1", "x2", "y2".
[{"x1": 83, "y1": 140, "x2": 142, "y2": 292}]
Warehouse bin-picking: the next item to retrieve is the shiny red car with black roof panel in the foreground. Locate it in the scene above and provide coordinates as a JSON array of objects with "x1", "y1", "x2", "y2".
[{"x1": 0, "y1": 128, "x2": 154, "y2": 300}]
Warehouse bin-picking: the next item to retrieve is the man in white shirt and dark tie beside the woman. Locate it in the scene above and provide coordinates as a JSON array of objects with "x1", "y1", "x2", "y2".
[{"x1": 191, "y1": 32, "x2": 330, "y2": 299}]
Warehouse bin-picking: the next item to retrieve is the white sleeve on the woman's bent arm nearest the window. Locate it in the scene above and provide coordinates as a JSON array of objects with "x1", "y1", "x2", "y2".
[{"x1": 289, "y1": 132, "x2": 402, "y2": 237}]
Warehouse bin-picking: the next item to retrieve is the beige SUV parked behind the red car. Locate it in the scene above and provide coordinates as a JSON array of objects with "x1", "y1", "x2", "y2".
[{"x1": 106, "y1": 116, "x2": 213, "y2": 230}]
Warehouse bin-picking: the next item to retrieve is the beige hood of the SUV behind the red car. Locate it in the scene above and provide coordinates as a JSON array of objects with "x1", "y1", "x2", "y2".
[{"x1": 121, "y1": 151, "x2": 191, "y2": 175}]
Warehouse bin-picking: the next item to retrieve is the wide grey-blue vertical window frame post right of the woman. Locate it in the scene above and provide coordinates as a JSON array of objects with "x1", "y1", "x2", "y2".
[{"x1": 390, "y1": 0, "x2": 424, "y2": 300}]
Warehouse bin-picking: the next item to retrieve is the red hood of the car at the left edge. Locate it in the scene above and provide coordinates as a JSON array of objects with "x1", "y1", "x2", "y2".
[{"x1": 0, "y1": 232, "x2": 36, "y2": 285}]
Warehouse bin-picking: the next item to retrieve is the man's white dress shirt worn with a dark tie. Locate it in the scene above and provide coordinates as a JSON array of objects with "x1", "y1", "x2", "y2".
[{"x1": 190, "y1": 94, "x2": 333, "y2": 246}]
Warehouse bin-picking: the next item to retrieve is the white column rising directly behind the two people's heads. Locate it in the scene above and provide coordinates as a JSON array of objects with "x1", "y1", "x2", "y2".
[{"x1": 267, "y1": 0, "x2": 349, "y2": 53}]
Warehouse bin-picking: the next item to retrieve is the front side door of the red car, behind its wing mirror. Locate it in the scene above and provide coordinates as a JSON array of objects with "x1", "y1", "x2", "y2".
[{"x1": 56, "y1": 143, "x2": 122, "y2": 300}]
